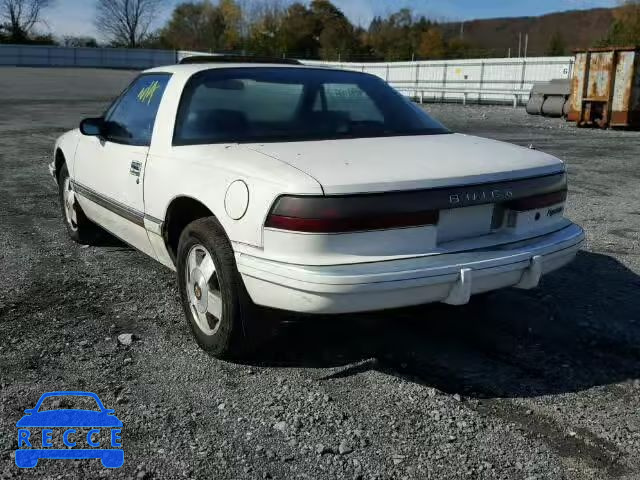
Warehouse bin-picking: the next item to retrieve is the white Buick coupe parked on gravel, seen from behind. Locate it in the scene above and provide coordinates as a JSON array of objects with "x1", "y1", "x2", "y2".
[{"x1": 50, "y1": 57, "x2": 584, "y2": 357}]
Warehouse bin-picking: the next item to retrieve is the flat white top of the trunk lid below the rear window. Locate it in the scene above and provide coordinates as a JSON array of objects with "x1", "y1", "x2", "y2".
[{"x1": 247, "y1": 134, "x2": 563, "y2": 195}]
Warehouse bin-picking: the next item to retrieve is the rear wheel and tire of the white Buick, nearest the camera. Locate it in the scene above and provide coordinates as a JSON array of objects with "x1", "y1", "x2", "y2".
[{"x1": 177, "y1": 217, "x2": 259, "y2": 359}]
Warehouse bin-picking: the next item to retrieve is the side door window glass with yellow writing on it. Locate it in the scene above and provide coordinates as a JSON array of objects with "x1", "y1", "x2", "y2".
[{"x1": 105, "y1": 74, "x2": 170, "y2": 145}]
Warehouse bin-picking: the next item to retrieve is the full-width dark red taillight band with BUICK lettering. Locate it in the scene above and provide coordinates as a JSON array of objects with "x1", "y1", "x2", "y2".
[{"x1": 265, "y1": 172, "x2": 567, "y2": 233}]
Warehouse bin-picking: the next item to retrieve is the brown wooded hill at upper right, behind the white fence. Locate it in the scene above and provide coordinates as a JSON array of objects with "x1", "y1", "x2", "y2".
[{"x1": 441, "y1": 8, "x2": 613, "y2": 57}]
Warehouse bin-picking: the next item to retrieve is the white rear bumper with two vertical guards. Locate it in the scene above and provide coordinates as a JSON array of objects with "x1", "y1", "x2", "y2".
[{"x1": 236, "y1": 224, "x2": 584, "y2": 313}]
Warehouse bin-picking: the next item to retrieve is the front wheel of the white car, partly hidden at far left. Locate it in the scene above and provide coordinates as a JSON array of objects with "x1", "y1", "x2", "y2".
[{"x1": 58, "y1": 164, "x2": 100, "y2": 245}]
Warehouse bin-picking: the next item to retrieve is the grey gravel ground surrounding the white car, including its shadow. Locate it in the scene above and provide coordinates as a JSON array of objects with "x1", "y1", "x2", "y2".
[{"x1": 0, "y1": 68, "x2": 640, "y2": 480}]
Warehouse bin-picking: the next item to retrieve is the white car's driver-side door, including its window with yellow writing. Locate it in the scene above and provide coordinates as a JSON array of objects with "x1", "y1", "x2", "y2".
[{"x1": 72, "y1": 73, "x2": 170, "y2": 256}]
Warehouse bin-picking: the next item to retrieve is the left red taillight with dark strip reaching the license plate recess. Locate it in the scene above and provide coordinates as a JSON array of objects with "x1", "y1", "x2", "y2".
[{"x1": 265, "y1": 196, "x2": 439, "y2": 233}]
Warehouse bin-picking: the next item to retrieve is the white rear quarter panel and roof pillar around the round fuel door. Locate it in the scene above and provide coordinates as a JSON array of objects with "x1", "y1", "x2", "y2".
[{"x1": 144, "y1": 69, "x2": 322, "y2": 251}]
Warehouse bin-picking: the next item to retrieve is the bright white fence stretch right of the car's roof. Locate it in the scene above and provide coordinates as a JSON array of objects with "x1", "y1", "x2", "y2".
[{"x1": 305, "y1": 57, "x2": 574, "y2": 103}]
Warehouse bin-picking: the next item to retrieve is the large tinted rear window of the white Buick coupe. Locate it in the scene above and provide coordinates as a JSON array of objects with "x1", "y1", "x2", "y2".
[{"x1": 173, "y1": 67, "x2": 449, "y2": 145}]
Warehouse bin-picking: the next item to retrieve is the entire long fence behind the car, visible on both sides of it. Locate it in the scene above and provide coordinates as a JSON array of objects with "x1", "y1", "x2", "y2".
[{"x1": 0, "y1": 45, "x2": 574, "y2": 104}]
